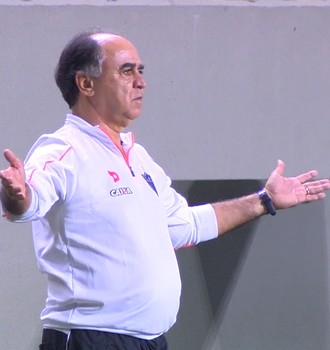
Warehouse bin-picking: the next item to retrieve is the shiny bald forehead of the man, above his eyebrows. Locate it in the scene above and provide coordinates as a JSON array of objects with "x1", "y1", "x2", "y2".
[{"x1": 93, "y1": 33, "x2": 141, "y2": 66}]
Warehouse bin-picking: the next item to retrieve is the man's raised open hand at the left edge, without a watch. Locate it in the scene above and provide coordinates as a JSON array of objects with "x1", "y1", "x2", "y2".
[{"x1": 0, "y1": 149, "x2": 31, "y2": 215}]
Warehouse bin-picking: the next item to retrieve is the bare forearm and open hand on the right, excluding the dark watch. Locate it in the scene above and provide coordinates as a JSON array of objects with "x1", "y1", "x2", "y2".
[{"x1": 212, "y1": 160, "x2": 330, "y2": 236}]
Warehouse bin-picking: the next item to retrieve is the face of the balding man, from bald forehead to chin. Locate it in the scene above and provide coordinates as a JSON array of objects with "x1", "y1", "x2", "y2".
[{"x1": 93, "y1": 34, "x2": 146, "y2": 131}]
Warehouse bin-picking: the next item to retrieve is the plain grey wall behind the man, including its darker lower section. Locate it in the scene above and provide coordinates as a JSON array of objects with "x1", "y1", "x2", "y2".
[{"x1": 0, "y1": 1, "x2": 330, "y2": 350}]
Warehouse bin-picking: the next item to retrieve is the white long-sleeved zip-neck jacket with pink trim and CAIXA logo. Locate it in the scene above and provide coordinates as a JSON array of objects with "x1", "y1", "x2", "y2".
[{"x1": 8, "y1": 114, "x2": 217, "y2": 339}]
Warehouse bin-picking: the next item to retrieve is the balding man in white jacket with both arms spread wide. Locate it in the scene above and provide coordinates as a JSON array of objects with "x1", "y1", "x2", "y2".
[{"x1": 0, "y1": 32, "x2": 330, "y2": 350}]
